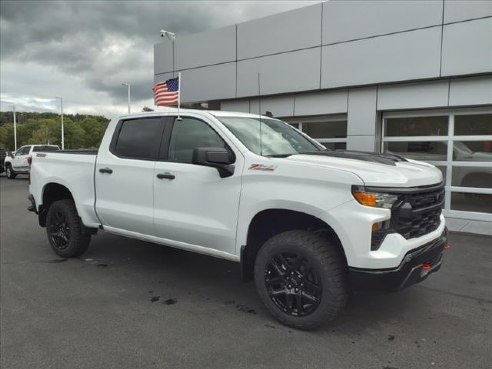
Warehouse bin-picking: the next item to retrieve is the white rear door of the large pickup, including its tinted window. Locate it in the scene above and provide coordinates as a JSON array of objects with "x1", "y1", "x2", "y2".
[{"x1": 94, "y1": 117, "x2": 169, "y2": 235}]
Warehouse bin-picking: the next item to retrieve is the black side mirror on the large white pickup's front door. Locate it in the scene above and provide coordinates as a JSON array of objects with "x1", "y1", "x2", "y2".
[{"x1": 191, "y1": 147, "x2": 236, "y2": 178}]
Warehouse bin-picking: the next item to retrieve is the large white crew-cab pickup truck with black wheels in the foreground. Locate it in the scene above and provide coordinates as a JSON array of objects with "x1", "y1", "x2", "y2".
[{"x1": 29, "y1": 109, "x2": 447, "y2": 329}]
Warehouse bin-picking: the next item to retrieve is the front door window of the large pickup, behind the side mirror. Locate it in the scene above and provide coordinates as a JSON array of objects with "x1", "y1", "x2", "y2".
[{"x1": 168, "y1": 118, "x2": 227, "y2": 164}]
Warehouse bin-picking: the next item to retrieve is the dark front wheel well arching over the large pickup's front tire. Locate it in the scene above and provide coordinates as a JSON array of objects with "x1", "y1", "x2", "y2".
[{"x1": 241, "y1": 209, "x2": 347, "y2": 282}]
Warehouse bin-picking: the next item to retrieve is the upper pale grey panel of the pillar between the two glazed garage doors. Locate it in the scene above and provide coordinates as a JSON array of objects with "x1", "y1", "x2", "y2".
[{"x1": 347, "y1": 87, "x2": 377, "y2": 136}]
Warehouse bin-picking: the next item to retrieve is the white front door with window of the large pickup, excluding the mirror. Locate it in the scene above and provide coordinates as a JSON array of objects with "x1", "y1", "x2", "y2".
[{"x1": 154, "y1": 117, "x2": 243, "y2": 254}]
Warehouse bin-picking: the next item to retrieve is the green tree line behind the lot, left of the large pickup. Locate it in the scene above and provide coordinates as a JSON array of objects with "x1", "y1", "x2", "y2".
[{"x1": 0, "y1": 112, "x2": 109, "y2": 151}]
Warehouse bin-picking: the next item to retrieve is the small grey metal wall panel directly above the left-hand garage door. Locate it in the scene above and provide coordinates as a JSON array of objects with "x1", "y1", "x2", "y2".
[{"x1": 294, "y1": 90, "x2": 348, "y2": 116}]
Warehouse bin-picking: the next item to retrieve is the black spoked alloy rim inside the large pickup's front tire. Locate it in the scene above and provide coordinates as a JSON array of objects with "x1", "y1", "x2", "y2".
[{"x1": 265, "y1": 252, "x2": 322, "y2": 316}]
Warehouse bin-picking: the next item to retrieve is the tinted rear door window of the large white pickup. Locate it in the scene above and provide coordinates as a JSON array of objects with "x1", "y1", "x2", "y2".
[{"x1": 112, "y1": 118, "x2": 164, "y2": 160}]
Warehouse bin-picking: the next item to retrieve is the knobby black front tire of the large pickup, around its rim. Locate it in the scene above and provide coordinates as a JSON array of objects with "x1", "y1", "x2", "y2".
[{"x1": 254, "y1": 230, "x2": 349, "y2": 330}]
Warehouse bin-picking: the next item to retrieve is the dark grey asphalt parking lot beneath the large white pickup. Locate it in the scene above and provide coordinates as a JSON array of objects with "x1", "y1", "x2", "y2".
[{"x1": 0, "y1": 174, "x2": 492, "y2": 369}]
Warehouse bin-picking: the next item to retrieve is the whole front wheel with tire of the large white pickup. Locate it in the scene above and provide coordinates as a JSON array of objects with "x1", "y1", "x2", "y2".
[{"x1": 255, "y1": 230, "x2": 348, "y2": 330}]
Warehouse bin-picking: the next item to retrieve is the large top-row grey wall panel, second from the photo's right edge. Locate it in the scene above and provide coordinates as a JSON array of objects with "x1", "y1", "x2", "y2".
[{"x1": 323, "y1": 0, "x2": 443, "y2": 44}]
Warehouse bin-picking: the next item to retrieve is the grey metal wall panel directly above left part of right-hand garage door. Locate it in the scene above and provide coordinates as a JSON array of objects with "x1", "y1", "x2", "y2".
[{"x1": 378, "y1": 81, "x2": 449, "y2": 110}]
